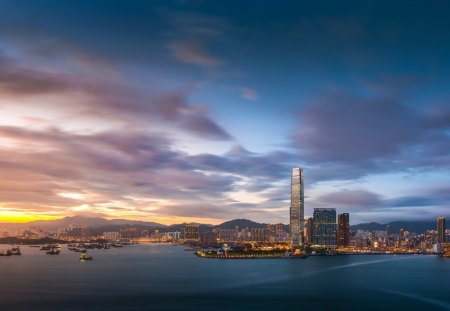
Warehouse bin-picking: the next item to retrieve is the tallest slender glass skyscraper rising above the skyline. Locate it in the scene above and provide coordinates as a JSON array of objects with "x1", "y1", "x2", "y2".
[{"x1": 290, "y1": 167, "x2": 305, "y2": 246}]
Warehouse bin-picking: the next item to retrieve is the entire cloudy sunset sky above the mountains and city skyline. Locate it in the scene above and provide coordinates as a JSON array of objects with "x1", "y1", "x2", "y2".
[{"x1": 0, "y1": 0, "x2": 450, "y2": 224}]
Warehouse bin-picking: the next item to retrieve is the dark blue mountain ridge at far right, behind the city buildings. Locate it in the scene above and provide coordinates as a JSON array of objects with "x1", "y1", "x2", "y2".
[{"x1": 351, "y1": 220, "x2": 436, "y2": 233}]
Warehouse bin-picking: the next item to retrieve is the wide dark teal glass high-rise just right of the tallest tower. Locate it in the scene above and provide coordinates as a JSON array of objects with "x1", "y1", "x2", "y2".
[{"x1": 313, "y1": 208, "x2": 336, "y2": 247}]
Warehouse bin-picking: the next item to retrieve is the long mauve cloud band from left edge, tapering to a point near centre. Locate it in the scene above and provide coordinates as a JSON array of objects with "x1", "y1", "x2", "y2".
[{"x1": 0, "y1": 55, "x2": 232, "y2": 140}]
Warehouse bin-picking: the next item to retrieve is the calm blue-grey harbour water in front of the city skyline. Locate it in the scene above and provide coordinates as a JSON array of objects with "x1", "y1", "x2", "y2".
[{"x1": 0, "y1": 244, "x2": 450, "y2": 311}]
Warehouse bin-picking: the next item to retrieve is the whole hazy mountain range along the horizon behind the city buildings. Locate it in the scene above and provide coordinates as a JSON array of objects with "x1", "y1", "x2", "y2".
[{"x1": 0, "y1": 216, "x2": 442, "y2": 234}]
